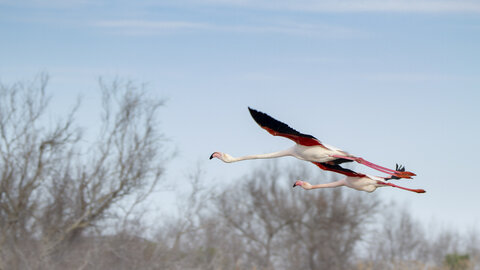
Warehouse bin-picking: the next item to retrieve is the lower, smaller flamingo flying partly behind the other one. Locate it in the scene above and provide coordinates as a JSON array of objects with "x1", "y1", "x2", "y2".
[{"x1": 293, "y1": 165, "x2": 425, "y2": 193}]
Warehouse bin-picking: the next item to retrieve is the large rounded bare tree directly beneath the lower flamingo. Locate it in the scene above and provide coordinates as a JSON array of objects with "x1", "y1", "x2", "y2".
[{"x1": 210, "y1": 163, "x2": 376, "y2": 269}]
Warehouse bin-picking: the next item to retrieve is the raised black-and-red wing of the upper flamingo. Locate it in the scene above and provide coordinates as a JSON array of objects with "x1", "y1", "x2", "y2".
[{"x1": 248, "y1": 107, "x2": 327, "y2": 148}]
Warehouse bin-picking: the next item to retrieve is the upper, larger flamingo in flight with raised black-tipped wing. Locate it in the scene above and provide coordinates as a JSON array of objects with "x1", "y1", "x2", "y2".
[{"x1": 210, "y1": 107, "x2": 415, "y2": 179}]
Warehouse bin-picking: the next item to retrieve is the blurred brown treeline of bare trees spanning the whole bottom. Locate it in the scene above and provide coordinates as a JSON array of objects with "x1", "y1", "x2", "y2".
[{"x1": 0, "y1": 76, "x2": 480, "y2": 270}]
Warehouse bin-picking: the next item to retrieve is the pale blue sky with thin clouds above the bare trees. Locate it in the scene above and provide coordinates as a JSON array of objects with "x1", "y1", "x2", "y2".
[{"x1": 0, "y1": 0, "x2": 480, "y2": 229}]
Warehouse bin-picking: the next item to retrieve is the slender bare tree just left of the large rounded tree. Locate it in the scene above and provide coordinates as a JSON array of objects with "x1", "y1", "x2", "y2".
[{"x1": 155, "y1": 167, "x2": 225, "y2": 269}]
